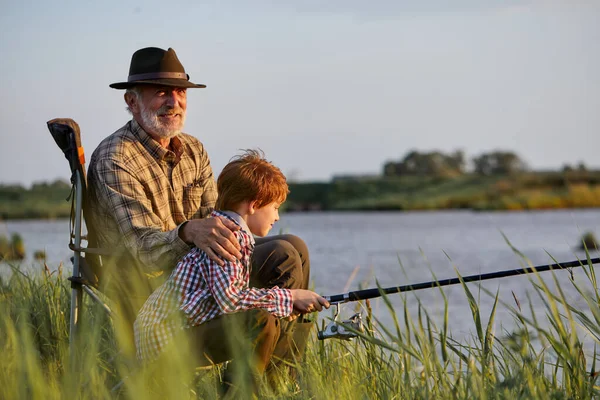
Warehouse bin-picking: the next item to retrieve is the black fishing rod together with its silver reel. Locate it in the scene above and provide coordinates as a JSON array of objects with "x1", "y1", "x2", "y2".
[{"x1": 318, "y1": 258, "x2": 600, "y2": 340}]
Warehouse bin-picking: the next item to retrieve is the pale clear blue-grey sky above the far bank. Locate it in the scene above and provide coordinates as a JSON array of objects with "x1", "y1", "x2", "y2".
[{"x1": 0, "y1": 0, "x2": 600, "y2": 185}]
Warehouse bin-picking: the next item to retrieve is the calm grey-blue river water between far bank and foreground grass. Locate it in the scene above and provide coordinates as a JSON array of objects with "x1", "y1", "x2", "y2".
[{"x1": 0, "y1": 209, "x2": 600, "y2": 346}]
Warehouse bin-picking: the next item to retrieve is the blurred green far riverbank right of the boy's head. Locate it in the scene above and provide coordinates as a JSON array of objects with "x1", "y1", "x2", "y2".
[{"x1": 286, "y1": 171, "x2": 600, "y2": 211}]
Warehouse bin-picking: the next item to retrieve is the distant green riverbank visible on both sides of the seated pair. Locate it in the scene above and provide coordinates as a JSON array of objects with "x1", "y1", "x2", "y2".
[{"x1": 0, "y1": 171, "x2": 600, "y2": 220}]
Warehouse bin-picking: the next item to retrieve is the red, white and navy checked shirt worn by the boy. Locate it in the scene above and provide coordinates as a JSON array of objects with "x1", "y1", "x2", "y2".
[{"x1": 134, "y1": 211, "x2": 293, "y2": 361}]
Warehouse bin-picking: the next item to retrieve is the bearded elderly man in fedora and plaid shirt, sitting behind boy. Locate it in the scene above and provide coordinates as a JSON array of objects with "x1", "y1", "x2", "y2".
[{"x1": 86, "y1": 47, "x2": 318, "y2": 372}]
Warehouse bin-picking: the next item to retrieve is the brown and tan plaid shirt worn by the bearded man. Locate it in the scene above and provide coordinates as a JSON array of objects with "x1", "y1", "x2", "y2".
[{"x1": 86, "y1": 119, "x2": 217, "y2": 272}]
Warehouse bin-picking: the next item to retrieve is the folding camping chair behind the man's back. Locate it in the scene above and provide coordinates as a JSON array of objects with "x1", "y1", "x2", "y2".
[{"x1": 47, "y1": 118, "x2": 112, "y2": 358}]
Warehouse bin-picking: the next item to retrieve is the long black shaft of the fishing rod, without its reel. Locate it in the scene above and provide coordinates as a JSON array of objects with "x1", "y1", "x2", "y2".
[{"x1": 323, "y1": 258, "x2": 600, "y2": 304}]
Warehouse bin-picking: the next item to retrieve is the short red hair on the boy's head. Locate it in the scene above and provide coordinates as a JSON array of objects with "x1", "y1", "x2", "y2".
[{"x1": 216, "y1": 150, "x2": 289, "y2": 210}]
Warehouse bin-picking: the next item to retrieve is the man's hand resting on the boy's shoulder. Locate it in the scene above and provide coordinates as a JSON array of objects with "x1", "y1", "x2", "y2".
[{"x1": 179, "y1": 217, "x2": 242, "y2": 266}]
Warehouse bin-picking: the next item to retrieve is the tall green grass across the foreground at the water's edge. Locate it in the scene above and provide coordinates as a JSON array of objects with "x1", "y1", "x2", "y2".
[{"x1": 0, "y1": 255, "x2": 600, "y2": 400}]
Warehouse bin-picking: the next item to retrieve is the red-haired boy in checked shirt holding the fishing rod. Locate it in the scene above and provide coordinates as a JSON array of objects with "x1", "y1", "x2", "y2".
[{"x1": 134, "y1": 150, "x2": 329, "y2": 374}]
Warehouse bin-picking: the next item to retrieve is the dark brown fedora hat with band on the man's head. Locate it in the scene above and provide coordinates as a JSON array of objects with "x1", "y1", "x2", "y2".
[{"x1": 109, "y1": 47, "x2": 206, "y2": 89}]
